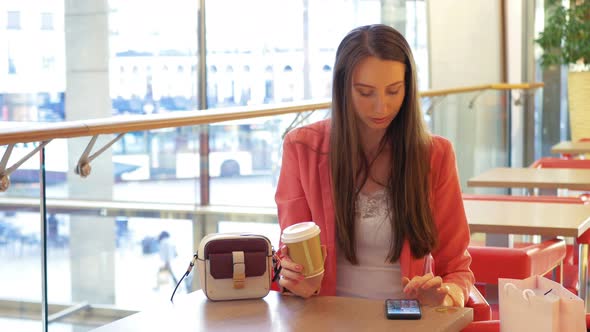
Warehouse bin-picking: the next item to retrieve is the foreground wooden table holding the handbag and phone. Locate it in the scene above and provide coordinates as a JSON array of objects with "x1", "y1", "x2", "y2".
[{"x1": 93, "y1": 290, "x2": 473, "y2": 332}]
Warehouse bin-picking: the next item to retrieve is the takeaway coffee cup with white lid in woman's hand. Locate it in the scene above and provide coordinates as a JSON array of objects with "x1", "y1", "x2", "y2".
[{"x1": 281, "y1": 221, "x2": 324, "y2": 278}]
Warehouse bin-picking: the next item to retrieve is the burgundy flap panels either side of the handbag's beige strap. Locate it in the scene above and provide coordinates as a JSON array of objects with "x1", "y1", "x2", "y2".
[{"x1": 209, "y1": 250, "x2": 267, "y2": 279}]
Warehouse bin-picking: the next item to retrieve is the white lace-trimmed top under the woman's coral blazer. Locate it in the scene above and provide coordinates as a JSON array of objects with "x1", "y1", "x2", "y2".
[{"x1": 336, "y1": 189, "x2": 402, "y2": 299}]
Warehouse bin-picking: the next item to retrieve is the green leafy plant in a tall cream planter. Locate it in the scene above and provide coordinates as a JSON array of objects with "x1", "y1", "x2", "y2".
[{"x1": 535, "y1": 0, "x2": 590, "y2": 141}]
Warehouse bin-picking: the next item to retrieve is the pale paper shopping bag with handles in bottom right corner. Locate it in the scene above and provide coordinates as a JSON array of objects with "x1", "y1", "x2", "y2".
[{"x1": 498, "y1": 276, "x2": 586, "y2": 332}]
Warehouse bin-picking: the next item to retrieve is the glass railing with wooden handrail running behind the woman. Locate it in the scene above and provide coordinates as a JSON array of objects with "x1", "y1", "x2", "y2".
[{"x1": 0, "y1": 85, "x2": 539, "y2": 331}]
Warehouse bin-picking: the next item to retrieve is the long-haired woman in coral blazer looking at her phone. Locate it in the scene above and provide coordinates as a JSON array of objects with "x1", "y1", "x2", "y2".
[{"x1": 275, "y1": 25, "x2": 474, "y2": 306}]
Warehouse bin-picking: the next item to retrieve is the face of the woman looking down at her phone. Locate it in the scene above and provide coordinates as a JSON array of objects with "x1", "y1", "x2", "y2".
[{"x1": 351, "y1": 56, "x2": 406, "y2": 134}]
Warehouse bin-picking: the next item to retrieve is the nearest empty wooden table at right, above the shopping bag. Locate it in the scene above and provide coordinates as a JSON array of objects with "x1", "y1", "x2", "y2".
[{"x1": 463, "y1": 200, "x2": 590, "y2": 312}]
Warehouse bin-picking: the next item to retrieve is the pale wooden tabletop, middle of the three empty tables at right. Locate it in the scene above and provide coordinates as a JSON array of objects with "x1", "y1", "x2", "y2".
[{"x1": 467, "y1": 167, "x2": 590, "y2": 190}]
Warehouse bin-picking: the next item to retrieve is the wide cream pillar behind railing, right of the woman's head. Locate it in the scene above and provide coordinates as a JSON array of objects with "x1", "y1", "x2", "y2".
[{"x1": 427, "y1": 0, "x2": 506, "y2": 192}]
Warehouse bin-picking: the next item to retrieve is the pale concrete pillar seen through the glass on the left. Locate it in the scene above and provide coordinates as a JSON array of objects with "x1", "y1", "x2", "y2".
[{"x1": 65, "y1": 0, "x2": 115, "y2": 304}]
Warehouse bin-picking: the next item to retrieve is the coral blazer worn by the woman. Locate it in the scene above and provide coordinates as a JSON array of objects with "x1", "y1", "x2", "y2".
[{"x1": 275, "y1": 119, "x2": 474, "y2": 300}]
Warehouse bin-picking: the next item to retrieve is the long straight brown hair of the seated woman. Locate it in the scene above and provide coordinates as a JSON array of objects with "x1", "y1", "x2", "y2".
[{"x1": 330, "y1": 24, "x2": 438, "y2": 264}]
